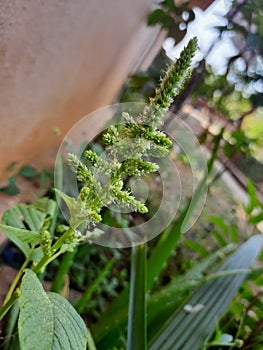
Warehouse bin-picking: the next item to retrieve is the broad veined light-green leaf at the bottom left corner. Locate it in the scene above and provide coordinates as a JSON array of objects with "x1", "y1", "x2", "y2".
[{"x1": 18, "y1": 270, "x2": 88, "y2": 350}]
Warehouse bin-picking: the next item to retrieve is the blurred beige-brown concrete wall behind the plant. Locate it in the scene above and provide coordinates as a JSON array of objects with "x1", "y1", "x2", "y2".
[{"x1": 0, "y1": 0, "x2": 163, "y2": 178}]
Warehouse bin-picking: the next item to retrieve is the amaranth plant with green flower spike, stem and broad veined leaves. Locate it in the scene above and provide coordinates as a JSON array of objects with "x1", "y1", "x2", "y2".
[{"x1": 0, "y1": 38, "x2": 197, "y2": 350}]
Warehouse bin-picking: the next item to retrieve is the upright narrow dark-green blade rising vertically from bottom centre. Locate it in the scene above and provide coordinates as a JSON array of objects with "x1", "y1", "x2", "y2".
[{"x1": 127, "y1": 244, "x2": 146, "y2": 350}]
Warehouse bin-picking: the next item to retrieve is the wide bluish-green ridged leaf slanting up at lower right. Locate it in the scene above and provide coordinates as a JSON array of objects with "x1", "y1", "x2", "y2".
[{"x1": 150, "y1": 235, "x2": 263, "y2": 350}]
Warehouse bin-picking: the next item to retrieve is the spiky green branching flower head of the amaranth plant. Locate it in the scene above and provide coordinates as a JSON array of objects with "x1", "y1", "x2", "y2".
[{"x1": 58, "y1": 38, "x2": 197, "y2": 229}]
